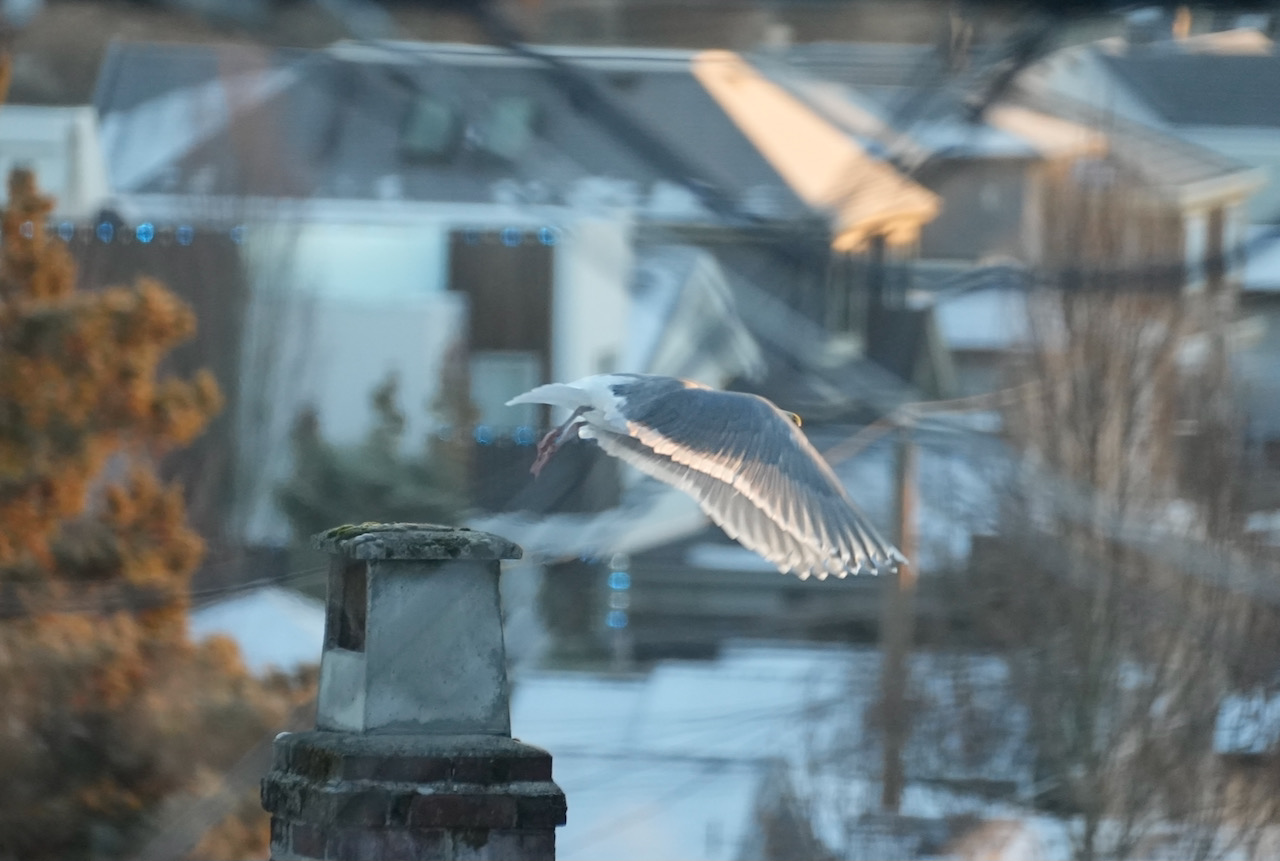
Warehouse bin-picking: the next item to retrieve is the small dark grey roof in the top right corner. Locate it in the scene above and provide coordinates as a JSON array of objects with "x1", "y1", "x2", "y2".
[{"x1": 1100, "y1": 50, "x2": 1280, "y2": 128}]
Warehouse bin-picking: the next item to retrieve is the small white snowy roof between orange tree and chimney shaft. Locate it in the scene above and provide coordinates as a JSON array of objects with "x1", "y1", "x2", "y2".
[{"x1": 189, "y1": 586, "x2": 324, "y2": 674}]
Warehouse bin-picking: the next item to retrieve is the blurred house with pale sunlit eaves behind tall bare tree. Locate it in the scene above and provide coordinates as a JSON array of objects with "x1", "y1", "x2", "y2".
[{"x1": 759, "y1": 43, "x2": 1265, "y2": 394}]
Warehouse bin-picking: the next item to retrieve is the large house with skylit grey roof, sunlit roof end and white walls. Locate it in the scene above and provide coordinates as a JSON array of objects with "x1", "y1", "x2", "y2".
[{"x1": 96, "y1": 43, "x2": 937, "y2": 541}]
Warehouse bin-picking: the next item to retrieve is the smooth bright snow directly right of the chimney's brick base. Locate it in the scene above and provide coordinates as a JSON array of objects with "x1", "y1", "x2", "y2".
[{"x1": 512, "y1": 647, "x2": 845, "y2": 860}]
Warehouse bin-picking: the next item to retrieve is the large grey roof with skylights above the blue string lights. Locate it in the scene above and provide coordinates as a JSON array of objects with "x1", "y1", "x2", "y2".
[{"x1": 95, "y1": 43, "x2": 812, "y2": 220}]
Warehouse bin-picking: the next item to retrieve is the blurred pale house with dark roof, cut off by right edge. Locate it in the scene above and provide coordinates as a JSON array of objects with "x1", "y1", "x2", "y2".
[{"x1": 1027, "y1": 27, "x2": 1280, "y2": 508}]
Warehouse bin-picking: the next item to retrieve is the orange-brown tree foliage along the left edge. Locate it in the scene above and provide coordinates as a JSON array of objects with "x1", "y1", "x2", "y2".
[{"x1": 0, "y1": 170, "x2": 306, "y2": 858}]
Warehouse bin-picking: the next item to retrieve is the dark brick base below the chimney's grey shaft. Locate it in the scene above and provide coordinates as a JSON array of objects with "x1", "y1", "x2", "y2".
[{"x1": 262, "y1": 732, "x2": 566, "y2": 861}]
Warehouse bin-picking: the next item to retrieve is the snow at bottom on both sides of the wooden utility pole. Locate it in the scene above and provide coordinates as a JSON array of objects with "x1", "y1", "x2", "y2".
[{"x1": 512, "y1": 644, "x2": 1039, "y2": 860}]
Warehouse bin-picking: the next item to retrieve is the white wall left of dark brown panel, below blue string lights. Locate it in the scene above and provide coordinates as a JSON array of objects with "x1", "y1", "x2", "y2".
[{"x1": 237, "y1": 223, "x2": 466, "y2": 544}]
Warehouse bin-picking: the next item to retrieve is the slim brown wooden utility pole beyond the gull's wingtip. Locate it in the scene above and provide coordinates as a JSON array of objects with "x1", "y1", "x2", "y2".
[{"x1": 881, "y1": 427, "x2": 918, "y2": 814}]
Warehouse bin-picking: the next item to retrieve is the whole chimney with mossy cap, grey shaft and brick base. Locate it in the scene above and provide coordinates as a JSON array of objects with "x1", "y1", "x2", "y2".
[{"x1": 262, "y1": 523, "x2": 566, "y2": 861}]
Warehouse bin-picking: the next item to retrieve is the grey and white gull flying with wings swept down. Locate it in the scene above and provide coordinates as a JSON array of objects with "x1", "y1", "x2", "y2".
[{"x1": 508, "y1": 374, "x2": 905, "y2": 578}]
